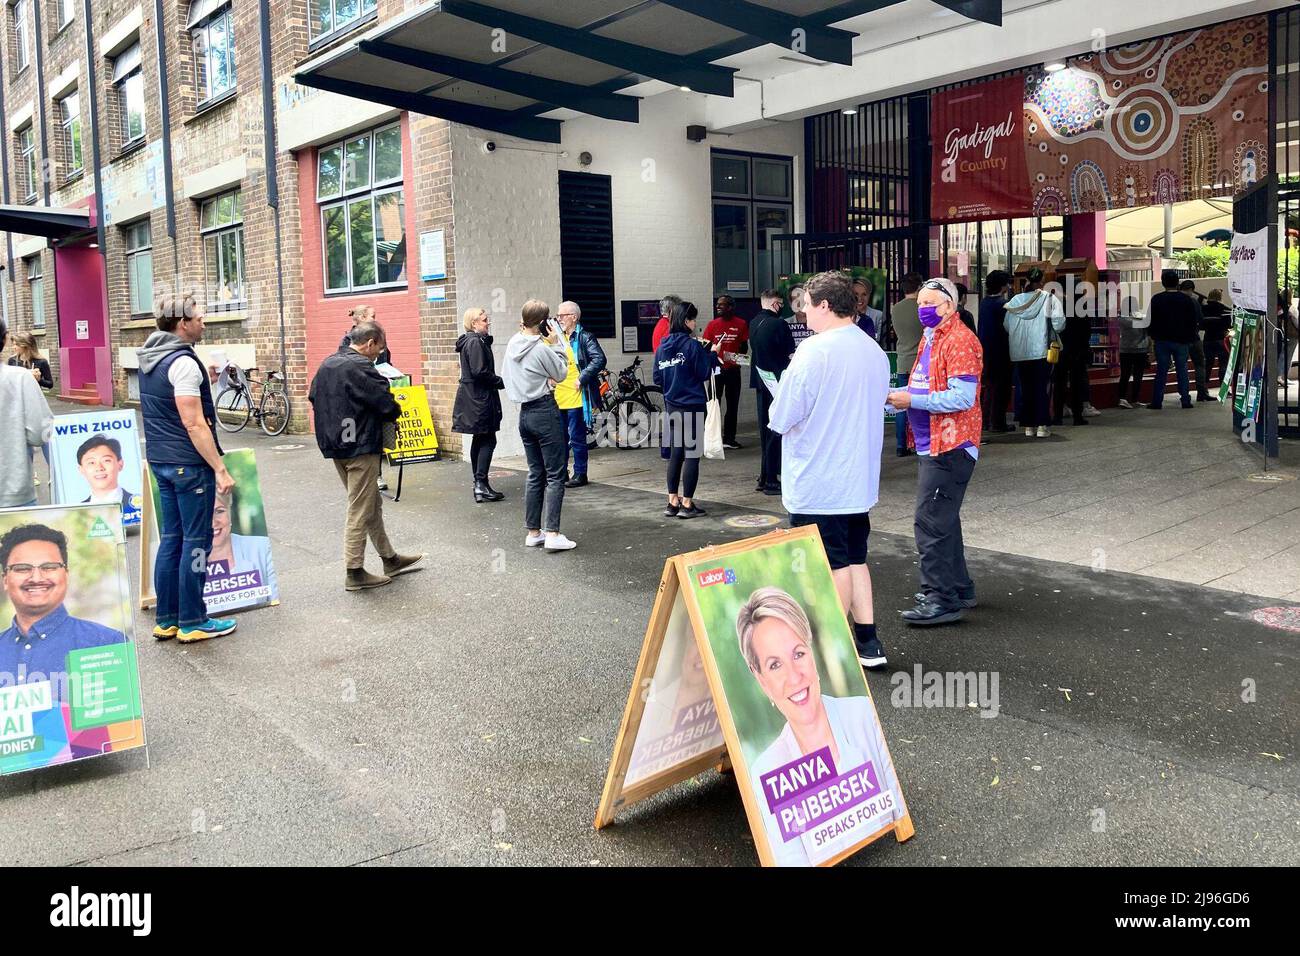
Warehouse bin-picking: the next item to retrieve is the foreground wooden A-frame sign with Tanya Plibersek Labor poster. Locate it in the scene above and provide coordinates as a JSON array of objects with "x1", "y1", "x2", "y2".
[{"x1": 595, "y1": 528, "x2": 915, "y2": 866}]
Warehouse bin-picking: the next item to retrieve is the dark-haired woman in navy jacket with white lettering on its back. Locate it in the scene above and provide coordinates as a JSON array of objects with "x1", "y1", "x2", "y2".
[{"x1": 654, "y1": 302, "x2": 720, "y2": 518}]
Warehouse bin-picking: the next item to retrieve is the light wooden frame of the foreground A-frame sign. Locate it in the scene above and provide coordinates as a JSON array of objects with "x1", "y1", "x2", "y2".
[{"x1": 595, "y1": 527, "x2": 915, "y2": 866}]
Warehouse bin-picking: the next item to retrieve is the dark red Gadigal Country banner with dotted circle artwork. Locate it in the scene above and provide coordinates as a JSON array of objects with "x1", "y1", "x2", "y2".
[{"x1": 931, "y1": 17, "x2": 1269, "y2": 221}]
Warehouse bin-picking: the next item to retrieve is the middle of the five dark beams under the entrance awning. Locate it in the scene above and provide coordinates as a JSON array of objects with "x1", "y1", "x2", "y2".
[{"x1": 442, "y1": 0, "x2": 736, "y2": 96}]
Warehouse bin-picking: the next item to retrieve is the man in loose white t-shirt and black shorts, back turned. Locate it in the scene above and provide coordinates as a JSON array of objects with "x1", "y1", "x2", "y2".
[{"x1": 768, "y1": 272, "x2": 889, "y2": 670}]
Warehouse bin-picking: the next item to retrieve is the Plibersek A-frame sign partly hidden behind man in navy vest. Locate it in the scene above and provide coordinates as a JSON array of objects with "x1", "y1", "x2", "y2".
[{"x1": 140, "y1": 449, "x2": 280, "y2": 615}]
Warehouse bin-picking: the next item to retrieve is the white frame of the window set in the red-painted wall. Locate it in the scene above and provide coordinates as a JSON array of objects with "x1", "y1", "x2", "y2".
[{"x1": 316, "y1": 120, "x2": 411, "y2": 295}]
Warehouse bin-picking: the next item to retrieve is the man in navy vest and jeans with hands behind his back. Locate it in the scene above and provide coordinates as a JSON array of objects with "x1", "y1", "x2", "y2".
[{"x1": 139, "y1": 294, "x2": 235, "y2": 644}]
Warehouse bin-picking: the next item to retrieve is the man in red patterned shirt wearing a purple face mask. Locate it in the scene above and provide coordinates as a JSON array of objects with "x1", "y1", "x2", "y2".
[{"x1": 889, "y1": 278, "x2": 984, "y2": 626}]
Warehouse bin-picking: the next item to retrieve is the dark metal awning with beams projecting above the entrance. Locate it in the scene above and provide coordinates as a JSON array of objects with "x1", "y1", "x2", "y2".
[{"x1": 294, "y1": 0, "x2": 1002, "y2": 143}]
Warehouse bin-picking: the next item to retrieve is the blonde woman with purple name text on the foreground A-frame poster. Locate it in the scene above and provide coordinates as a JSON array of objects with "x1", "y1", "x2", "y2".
[{"x1": 736, "y1": 588, "x2": 906, "y2": 866}]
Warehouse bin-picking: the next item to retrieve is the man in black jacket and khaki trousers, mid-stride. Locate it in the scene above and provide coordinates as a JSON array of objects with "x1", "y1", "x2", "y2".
[{"x1": 307, "y1": 323, "x2": 424, "y2": 591}]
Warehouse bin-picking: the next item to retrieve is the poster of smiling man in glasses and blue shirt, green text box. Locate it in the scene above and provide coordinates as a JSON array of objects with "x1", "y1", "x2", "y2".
[{"x1": 0, "y1": 503, "x2": 144, "y2": 775}]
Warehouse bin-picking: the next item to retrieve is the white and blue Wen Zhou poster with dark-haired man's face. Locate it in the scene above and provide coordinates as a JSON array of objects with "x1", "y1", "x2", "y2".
[{"x1": 49, "y1": 408, "x2": 144, "y2": 527}]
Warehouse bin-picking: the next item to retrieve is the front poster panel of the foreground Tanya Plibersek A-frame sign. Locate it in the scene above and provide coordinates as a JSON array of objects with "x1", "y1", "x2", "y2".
[{"x1": 684, "y1": 529, "x2": 913, "y2": 866}]
